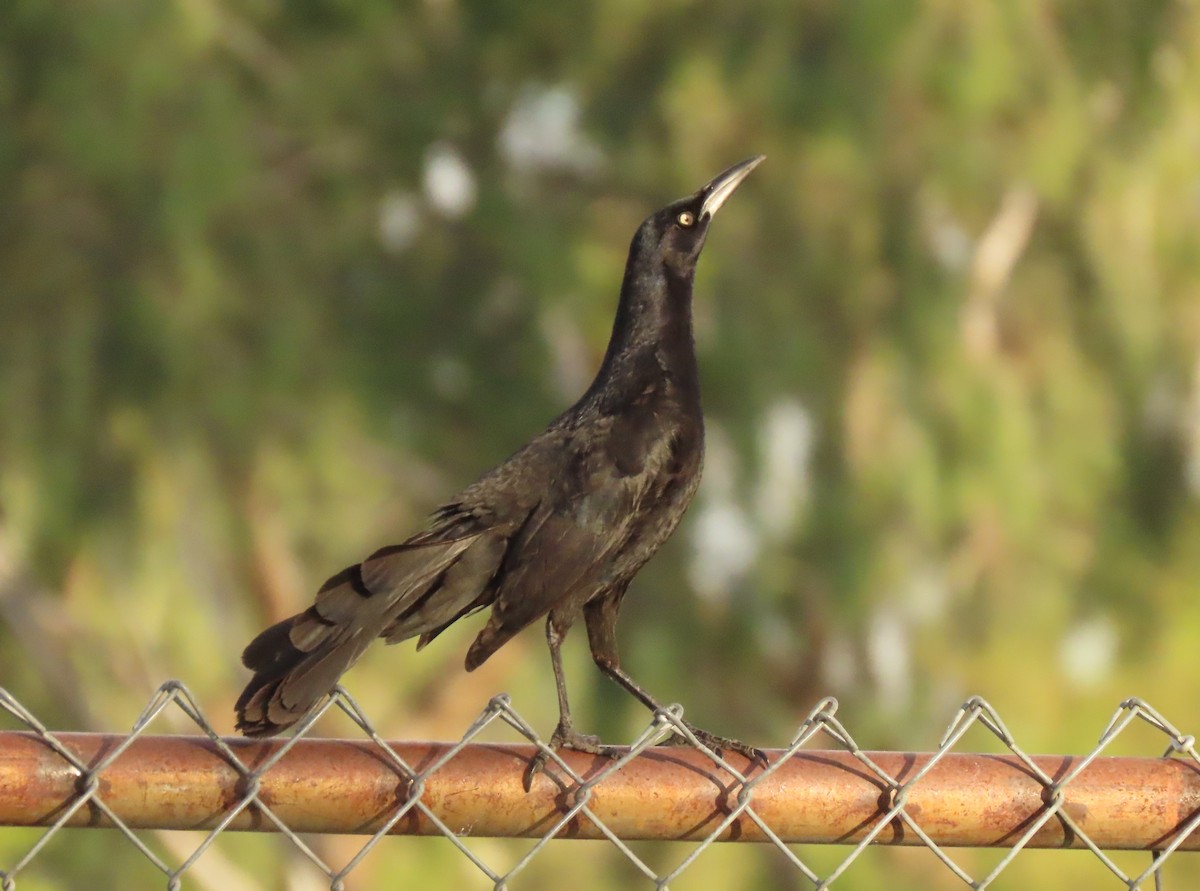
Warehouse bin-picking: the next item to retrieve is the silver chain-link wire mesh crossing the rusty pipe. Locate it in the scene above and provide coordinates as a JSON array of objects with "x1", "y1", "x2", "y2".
[{"x1": 0, "y1": 681, "x2": 1200, "y2": 891}]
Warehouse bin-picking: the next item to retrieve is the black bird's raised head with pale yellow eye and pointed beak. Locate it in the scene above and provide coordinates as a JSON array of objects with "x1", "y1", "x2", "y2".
[{"x1": 632, "y1": 155, "x2": 766, "y2": 277}]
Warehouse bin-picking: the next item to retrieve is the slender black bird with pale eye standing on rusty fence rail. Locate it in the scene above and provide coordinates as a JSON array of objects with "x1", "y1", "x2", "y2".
[{"x1": 236, "y1": 155, "x2": 763, "y2": 761}]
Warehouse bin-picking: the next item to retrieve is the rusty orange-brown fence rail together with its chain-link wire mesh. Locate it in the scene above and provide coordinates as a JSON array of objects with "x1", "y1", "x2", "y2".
[{"x1": 0, "y1": 681, "x2": 1200, "y2": 891}]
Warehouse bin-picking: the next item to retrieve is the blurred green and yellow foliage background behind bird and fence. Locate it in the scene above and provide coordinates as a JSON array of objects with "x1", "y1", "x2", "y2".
[{"x1": 0, "y1": 0, "x2": 1200, "y2": 889}]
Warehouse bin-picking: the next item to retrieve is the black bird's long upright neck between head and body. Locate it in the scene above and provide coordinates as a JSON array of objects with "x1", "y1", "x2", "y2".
[{"x1": 592, "y1": 264, "x2": 700, "y2": 412}]
